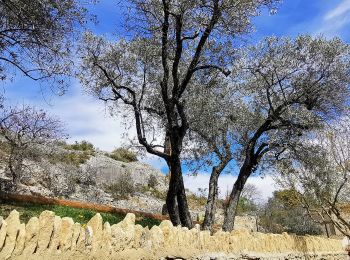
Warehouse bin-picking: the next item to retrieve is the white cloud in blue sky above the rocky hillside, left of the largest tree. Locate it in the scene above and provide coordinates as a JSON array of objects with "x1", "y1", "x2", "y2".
[{"x1": 6, "y1": 84, "x2": 135, "y2": 151}]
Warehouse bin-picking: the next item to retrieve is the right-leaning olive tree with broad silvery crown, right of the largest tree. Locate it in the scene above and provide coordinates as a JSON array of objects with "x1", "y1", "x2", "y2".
[{"x1": 223, "y1": 36, "x2": 350, "y2": 231}]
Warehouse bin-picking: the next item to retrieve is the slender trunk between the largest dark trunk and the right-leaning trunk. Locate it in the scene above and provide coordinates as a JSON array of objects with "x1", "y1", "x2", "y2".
[{"x1": 202, "y1": 159, "x2": 230, "y2": 231}]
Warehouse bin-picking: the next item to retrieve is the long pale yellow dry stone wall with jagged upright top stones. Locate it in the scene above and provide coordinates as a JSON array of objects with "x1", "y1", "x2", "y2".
[{"x1": 0, "y1": 210, "x2": 345, "y2": 260}]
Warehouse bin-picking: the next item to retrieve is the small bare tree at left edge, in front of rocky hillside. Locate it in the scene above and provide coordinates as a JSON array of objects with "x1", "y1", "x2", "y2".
[{"x1": 0, "y1": 106, "x2": 64, "y2": 189}]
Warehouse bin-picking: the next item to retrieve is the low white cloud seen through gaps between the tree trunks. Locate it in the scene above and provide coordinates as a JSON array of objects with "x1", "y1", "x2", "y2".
[{"x1": 184, "y1": 173, "x2": 277, "y2": 201}]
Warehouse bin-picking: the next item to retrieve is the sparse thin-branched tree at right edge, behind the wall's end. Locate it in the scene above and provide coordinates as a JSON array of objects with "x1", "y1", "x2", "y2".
[{"x1": 278, "y1": 116, "x2": 350, "y2": 237}]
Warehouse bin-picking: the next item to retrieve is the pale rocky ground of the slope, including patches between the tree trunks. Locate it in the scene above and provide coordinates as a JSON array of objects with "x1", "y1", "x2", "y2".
[{"x1": 0, "y1": 144, "x2": 256, "y2": 230}]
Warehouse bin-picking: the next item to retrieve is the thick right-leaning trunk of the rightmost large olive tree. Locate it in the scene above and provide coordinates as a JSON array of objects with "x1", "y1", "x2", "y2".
[{"x1": 222, "y1": 163, "x2": 252, "y2": 231}]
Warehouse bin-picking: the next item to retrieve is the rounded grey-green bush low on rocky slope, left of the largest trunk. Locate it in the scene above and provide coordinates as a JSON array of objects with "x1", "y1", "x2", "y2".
[{"x1": 106, "y1": 173, "x2": 136, "y2": 199}]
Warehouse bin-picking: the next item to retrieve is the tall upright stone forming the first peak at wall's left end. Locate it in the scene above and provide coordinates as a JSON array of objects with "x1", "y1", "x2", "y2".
[{"x1": 0, "y1": 210, "x2": 21, "y2": 259}]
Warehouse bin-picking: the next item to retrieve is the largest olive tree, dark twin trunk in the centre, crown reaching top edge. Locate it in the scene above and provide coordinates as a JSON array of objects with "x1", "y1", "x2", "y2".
[{"x1": 80, "y1": 0, "x2": 275, "y2": 227}]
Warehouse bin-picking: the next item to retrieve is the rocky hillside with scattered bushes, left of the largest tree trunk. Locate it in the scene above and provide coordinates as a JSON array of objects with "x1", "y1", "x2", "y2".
[{"x1": 0, "y1": 143, "x2": 167, "y2": 213}]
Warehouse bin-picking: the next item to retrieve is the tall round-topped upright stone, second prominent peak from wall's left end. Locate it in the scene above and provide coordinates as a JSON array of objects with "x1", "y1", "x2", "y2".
[{"x1": 37, "y1": 210, "x2": 55, "y2": 252}]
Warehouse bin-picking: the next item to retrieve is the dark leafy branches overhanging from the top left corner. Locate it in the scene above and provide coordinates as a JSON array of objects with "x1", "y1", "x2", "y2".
[{"x1": 0, "y1": 0, "x2": 86, "y2": 89}]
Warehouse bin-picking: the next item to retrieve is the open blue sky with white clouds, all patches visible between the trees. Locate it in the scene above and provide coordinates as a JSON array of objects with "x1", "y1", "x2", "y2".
[{"x1": 0, "y1": 0, "x2": 350, "y2": 197}]
